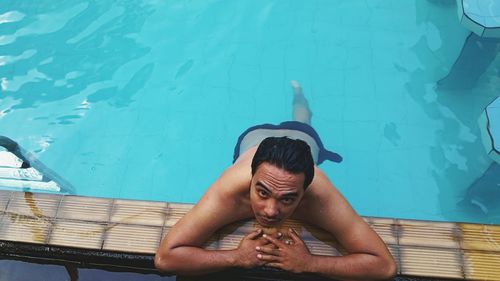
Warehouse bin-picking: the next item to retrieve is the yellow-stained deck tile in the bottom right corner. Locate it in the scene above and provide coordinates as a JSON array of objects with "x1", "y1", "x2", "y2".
[{"x1": 463, "y1": 250, "x2": 500, "y2": 280}]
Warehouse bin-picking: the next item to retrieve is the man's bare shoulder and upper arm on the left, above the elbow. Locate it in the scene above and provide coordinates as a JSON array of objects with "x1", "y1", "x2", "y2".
[{"x1": 160, "y1": 148, "x2": 252, "y2": 249}]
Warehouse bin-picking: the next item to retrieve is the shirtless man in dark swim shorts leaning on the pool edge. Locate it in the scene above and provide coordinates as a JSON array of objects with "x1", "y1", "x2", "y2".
[{"x1": 155, "y1": 81, "x2": 396, "y2": 280}]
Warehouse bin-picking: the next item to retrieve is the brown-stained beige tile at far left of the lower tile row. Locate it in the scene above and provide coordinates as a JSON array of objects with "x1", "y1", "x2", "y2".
[{"x1": 0, "y1": 213, "x2": 52, "y2": 244}]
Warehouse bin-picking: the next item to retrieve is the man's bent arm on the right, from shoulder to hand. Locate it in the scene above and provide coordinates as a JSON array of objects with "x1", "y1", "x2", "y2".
[{"x1": 260, "y1": 169, "x2": 396, "y2": 280}]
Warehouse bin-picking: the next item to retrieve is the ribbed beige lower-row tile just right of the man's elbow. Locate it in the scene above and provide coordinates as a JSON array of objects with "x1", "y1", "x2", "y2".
[{"x1": 399, "y1": 246, "x2": 463, "y2": 279}]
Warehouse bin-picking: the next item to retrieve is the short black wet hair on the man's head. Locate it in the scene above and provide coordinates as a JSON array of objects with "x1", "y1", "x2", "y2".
[{"x1": 252, "y1": 137, "x2": 314, "y2": 190}]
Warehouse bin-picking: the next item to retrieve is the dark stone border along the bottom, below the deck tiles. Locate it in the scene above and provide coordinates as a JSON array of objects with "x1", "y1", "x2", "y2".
[{"x1": 0, "y1": 240, "x2": 453, "y2": 281}]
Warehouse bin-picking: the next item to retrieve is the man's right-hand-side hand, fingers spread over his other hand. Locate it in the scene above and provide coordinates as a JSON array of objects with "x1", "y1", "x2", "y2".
[{"x1": 256, "y1": 228, "x2": 311, "y2": 273}]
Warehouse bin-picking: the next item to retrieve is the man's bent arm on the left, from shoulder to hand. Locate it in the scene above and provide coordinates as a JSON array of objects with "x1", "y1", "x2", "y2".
[{"x1": 155, "y1": 148, "x2": 276, "y2": 275}]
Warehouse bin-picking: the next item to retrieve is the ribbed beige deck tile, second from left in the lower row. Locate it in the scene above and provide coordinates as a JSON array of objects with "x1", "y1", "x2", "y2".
[{"x1": 49, "y1": 220, "x2": 107, "y2": 249}]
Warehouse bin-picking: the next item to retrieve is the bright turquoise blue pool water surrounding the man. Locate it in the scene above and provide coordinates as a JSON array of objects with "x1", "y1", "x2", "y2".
[{"x1": 0, "y1": 0, "x2": 500, "y2": 223}]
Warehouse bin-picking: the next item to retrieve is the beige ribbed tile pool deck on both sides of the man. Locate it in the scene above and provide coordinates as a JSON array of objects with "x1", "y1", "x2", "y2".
[{"x1": 0, "y1": 191, "x2": 500, "y2": 280}]
